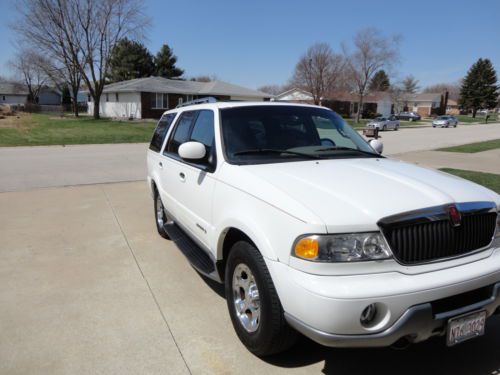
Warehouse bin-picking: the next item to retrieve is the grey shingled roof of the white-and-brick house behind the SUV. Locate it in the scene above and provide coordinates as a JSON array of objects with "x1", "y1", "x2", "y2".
[{"x1": 97, "y1": 77, "x2": 272, "y2": 98}]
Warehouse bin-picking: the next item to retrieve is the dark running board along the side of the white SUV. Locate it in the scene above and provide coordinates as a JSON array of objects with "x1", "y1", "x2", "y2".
[{"x1": 164, "y1": 222, "x2": 221, "y2": 282}]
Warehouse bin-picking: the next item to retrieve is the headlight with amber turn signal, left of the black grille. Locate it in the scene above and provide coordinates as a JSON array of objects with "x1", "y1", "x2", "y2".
[{"x1": 292, "y1": 232, "x2": 392, "y2": 262}]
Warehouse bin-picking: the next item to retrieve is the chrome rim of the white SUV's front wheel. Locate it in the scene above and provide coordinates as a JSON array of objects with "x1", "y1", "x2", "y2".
[{"x1": 232, "y1": 263, "x2": 260, "y2": 333}]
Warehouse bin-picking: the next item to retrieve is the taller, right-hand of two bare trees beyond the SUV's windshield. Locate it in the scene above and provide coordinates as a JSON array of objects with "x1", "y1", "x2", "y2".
[{"x1": 343, "y1": 28, "x2": 400, "y2": 122}]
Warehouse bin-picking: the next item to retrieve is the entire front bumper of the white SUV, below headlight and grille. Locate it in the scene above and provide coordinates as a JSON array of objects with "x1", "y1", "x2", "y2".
[{"x1": 266, "y1": 248, "x2": 500, "y2": 347}]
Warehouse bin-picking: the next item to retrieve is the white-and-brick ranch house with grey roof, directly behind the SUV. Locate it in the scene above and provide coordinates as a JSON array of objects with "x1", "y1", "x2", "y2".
[{"x1": 88, "y1": 77, "x2": 272, "y2": 118}]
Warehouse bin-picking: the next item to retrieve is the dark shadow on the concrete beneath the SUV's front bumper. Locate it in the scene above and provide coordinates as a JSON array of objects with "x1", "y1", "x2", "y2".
[{"x1": 265, "y1": 316, "x2": 500, "y2": 375}]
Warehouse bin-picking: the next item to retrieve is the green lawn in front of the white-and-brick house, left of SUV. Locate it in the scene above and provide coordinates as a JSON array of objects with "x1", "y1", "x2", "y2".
[{"x1": 0, "y1": 113, "x2": 155, "y2": 146}]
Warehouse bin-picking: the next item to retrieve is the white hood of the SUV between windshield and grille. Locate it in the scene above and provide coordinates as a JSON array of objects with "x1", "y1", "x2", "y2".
[{"x1": 221, "y1": 158, "x2": 500, "y2": 232}]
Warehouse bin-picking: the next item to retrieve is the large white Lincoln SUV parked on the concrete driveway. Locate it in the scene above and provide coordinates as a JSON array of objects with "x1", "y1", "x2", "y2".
[{"x1": 147, "y1": 100, "x2": 500, "y2": 356}]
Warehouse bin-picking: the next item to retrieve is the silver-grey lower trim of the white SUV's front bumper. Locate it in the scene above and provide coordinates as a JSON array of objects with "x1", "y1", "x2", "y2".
[{"x1": 285, "y1": 283, "x2": 500, "y2": 348}]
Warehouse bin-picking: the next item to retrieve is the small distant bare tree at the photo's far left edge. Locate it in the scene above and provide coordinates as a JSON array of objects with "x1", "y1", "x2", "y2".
[{"x1": 9, "y1": 49, "x2": 48, "y2": 103}]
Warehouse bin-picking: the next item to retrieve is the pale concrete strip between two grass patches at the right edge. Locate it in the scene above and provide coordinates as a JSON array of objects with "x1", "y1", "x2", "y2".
[{"x1": 393, "y1": 149, "x2": 500, "y2": 175}]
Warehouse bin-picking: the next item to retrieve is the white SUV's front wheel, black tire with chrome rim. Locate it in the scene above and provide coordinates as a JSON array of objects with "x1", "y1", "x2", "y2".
[{"x1": 225, "y1": 241, "x2": 297, "y2": 357}]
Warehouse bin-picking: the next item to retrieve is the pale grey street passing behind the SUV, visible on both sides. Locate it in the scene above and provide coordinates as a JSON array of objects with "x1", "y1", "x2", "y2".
[{"x1": 0, "y1": 124, "x2": 500, "y2": 192}]
